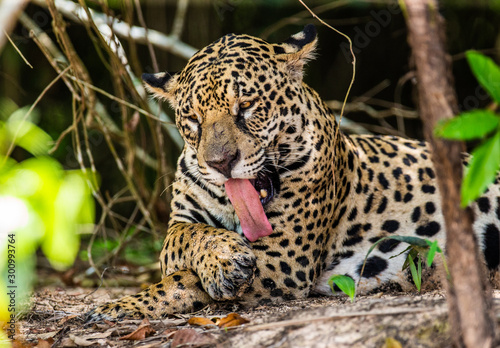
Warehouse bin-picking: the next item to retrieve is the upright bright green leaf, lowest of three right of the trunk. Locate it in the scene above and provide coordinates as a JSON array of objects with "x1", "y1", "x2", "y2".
[{"x1": 461, "y1": 130, "x2": 500, "y2": 207}]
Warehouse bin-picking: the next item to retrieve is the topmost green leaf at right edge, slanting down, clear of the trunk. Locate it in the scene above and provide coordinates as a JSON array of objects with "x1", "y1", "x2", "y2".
[{"x1": 465, "y1": 51, "x2": 500, "y2": 103}]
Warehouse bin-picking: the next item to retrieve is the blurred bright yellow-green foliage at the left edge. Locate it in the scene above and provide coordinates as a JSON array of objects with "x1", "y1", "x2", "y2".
[{"x1": 0, "y1": 100, "x2": 95, "y2": 322}]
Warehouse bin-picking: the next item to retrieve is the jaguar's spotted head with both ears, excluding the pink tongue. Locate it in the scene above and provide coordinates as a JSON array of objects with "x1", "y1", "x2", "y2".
[{"x1": 143, "y1": 26, "x2": 316, "y2": 204}]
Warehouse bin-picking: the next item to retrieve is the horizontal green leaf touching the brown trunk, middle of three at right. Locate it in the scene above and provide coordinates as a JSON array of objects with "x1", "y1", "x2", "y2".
[{"x1": 434, "y1": 110, "x2": 500, "y2": 140}]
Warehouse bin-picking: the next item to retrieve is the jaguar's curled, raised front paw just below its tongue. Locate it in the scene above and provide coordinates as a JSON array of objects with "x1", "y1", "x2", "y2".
[{"x1": 198, "y1": 236, "x2": 256, "y2": 301}]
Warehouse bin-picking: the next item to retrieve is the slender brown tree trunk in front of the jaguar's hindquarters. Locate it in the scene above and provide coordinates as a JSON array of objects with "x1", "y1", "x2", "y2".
[{"x1": 404, "y1": 0, "x2": 495, "y2": 347}]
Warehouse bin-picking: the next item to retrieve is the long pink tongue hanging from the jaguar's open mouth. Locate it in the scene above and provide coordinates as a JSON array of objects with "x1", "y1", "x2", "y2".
[{"x1": 224, "y1": 179, "x2": 273, "y2": 242}]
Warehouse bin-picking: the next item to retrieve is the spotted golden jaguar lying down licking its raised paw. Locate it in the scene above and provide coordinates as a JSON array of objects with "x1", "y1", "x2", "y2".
[{"x1": 89, "y1": 25, "x2": 500, "y2": 320}]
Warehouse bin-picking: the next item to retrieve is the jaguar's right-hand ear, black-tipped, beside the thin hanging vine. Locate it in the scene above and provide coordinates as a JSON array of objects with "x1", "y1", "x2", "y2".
[{"x1": 274, "y1": 24, "x2": 318, "y2": 80}]
